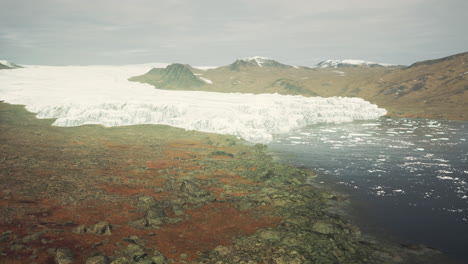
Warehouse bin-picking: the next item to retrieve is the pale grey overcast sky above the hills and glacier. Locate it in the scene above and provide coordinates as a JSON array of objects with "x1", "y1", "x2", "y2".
[{"x1": 0, "y1": 0, "x2": 468, "y2": 66}]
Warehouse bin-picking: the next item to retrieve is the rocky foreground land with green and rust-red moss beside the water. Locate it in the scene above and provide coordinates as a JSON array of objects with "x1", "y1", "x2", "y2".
[{"x1": 0, "y1": 103, "x2": 458, "y2": 264}]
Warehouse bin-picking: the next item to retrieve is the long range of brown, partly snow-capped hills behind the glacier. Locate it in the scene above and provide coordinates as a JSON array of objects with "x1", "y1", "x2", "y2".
[{"x1": 131, "y1": 53, "x2": 468, "y2": 119}]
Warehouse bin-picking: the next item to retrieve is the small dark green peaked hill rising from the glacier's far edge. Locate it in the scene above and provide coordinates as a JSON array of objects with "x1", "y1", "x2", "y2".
[{"x1": 129, "y1": 63, "x2": 210, "y2": 90}]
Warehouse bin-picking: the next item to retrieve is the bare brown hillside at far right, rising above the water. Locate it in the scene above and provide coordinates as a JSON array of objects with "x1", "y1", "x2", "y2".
[{"x1": 366, "y1": 52, "x2": 468, "y2": 119}]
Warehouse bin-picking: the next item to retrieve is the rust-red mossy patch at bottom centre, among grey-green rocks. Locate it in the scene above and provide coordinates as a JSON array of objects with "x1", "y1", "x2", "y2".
[{"x1": 155, "y1": 203, "x2": 281, "y2": 260}]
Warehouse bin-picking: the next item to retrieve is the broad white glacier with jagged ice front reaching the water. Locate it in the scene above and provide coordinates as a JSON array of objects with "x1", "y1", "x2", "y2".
[{"x1": 0, "y1": 65, "x2": 386, "y2": 143}]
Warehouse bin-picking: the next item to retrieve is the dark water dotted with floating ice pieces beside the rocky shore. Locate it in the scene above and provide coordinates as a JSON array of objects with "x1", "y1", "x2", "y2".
[{"x1": 269, "y1": 118, "x2": 468, "y2": 261}]
